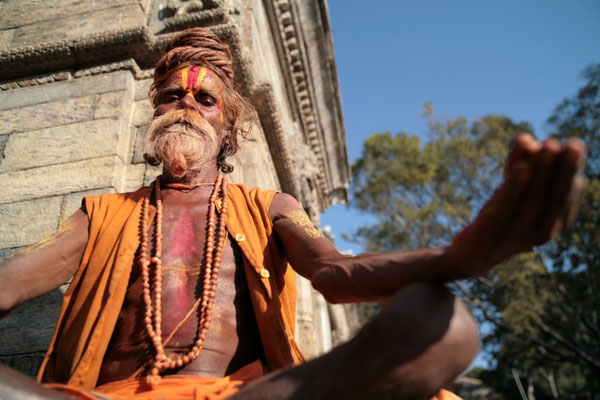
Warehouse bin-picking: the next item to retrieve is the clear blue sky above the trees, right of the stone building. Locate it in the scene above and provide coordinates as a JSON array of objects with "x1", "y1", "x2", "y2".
[{"x1": 322, "y1": 0, "x2": 600, "y2": 253}]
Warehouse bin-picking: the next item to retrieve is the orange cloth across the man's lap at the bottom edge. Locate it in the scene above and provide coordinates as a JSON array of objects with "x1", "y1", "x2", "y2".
[{"x1": 45, "y1": 360, "x2": 263, "y2": 400}]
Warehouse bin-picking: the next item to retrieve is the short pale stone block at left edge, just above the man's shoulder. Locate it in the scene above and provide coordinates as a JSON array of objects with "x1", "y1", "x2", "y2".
[{"x1": 0, "y1": 195, "x2": 62, "y2": 248}]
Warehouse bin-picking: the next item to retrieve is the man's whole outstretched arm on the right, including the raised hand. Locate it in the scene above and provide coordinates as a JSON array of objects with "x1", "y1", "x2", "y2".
[{"x1": 270, "y1": 134, "x2": 585, "y2": 303}]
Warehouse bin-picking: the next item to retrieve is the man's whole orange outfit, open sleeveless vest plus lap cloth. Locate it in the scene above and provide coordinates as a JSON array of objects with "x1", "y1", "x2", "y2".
[{"x1": 38, "y1": 184, "x2": 457, "y2": 400}]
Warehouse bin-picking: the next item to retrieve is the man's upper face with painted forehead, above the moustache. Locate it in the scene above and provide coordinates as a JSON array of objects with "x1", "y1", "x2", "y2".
[{"x1": 154, "y1": 66, "x2": 224, "y2": 134}]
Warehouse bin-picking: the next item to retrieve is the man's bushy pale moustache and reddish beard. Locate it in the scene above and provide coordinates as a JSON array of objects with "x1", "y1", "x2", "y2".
[{"x1": 144, "y1": 109, "x2": 219, "y2": 182}]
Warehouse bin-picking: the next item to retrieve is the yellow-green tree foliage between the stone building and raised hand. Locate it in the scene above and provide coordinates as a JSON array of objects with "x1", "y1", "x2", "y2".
[{"x1": 352, "y1": 111, "x2": 530, "y2": 251}]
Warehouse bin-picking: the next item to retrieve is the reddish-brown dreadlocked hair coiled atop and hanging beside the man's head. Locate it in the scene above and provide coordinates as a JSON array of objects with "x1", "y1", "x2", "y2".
[{"x1": 150, "y1": 27, "x2": 257, "y2": 174}]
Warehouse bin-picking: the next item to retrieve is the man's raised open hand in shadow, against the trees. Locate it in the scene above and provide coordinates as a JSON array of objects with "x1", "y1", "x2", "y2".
[{"x1": 450, "y1": 133, "x2": 586, "y2": 278}]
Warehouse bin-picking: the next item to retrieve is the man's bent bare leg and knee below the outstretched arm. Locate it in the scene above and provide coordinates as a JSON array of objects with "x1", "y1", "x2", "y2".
[{"x1": 230, "y1": 283, "x2": 478, "y2": 400}]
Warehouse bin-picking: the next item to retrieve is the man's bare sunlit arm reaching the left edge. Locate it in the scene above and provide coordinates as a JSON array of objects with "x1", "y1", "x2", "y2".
[{"x1": 0, "y1": 209, "x2": 89, "y2": 316}]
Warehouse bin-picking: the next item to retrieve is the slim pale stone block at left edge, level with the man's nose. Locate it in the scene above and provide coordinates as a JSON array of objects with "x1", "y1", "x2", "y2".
[{"x1": 0, "y1": 95, "x2": 96, "y2": 135}]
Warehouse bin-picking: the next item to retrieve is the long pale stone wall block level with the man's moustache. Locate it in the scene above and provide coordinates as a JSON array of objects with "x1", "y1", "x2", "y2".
[{"x1": 0, "y1": 119, "x2": 119, "y2": 173}]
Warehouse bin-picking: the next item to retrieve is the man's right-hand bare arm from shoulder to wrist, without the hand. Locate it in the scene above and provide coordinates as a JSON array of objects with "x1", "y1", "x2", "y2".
[{"x1": 270, "y1": 194, "x2": 448, "y2": 303}]
